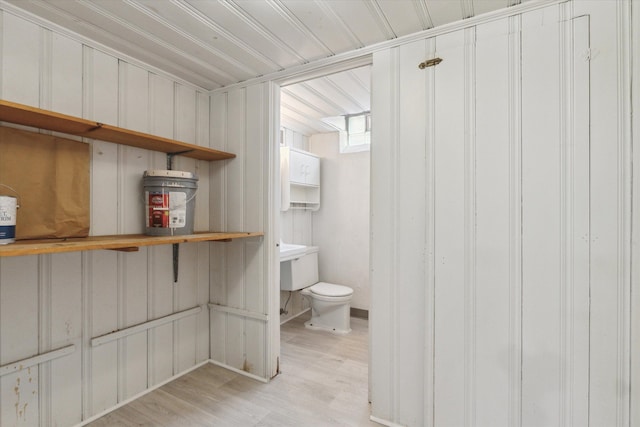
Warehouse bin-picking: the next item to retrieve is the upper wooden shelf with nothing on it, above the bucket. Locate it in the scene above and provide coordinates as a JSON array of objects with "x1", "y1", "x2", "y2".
[{"x1": 0, "y1": 100, "x2": 236, "y2": 161}]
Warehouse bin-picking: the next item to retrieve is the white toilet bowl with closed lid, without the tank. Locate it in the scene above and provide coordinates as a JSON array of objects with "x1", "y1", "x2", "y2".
[{"x1": 300, "y1": 282, "x2": 353, "y2": 334}]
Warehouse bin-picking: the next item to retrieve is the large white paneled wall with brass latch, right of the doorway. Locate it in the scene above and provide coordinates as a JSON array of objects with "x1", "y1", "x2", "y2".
[{"x1": 370, "y1": 1, "x2": 638, "y2": 426}]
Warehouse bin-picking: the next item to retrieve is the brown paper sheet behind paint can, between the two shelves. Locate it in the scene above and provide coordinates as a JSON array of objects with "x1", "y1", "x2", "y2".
[{"x1": 0, "y1": 126, "x2": 90, "y2": 240}]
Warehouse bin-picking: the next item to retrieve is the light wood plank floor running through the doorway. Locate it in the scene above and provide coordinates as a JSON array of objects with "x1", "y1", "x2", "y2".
[{"x1": 89, "y1": 313, "x2": 378, "y2": 427}]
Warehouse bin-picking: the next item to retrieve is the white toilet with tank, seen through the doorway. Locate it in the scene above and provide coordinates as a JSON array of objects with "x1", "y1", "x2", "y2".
[{"x1": 280, "y1": 246, "x2": 353, "y2": 334}]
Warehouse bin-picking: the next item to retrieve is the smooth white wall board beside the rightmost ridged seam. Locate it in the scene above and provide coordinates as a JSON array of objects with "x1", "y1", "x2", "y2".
[{"x1": 574, "y1": 2, "x2": 624, "y2": 426}]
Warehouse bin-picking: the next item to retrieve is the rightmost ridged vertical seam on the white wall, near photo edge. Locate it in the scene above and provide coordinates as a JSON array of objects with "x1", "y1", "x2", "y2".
[{"x1": 616, "y1": 1, "x2": 632, "y2": 426}]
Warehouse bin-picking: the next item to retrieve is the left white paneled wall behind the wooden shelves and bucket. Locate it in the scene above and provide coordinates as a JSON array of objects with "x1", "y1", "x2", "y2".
[{"x1": 0, "y1": 11, "x2": 211, "y2": 426}]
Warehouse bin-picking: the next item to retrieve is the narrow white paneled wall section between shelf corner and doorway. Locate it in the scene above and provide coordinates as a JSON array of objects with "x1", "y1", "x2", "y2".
[{"x1": 210, "y1": 83, "x2": 280, "y2": 380}]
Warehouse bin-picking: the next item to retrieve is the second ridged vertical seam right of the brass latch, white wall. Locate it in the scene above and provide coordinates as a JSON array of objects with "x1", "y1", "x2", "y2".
[{"x1": 508, "y1": 15, "x2": 522, "y2": 427}]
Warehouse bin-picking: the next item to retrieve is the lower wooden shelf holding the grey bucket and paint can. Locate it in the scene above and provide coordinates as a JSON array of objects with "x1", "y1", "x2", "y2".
[{"x1": 0, "y1": 231, "x2": 264, "y2": 257}]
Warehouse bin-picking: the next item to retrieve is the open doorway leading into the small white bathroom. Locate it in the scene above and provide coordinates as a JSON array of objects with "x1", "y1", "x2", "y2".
[{"x1": 277, "y1": 63, "x2": 371, "y2": 414}]
